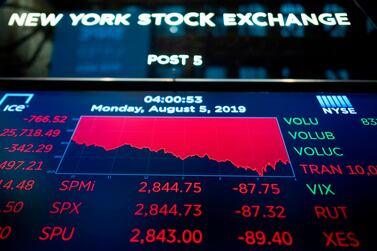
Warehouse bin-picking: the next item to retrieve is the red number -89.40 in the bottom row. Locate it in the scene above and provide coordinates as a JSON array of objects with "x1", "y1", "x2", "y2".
[{"x1": 238, "y1": 230, "x2": 293, "y2": 246}]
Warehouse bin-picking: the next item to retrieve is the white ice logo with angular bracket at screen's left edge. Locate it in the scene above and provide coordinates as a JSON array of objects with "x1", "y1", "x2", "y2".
[{"x1": 0, "y1": 93, "x2": 34, "y2": 112}]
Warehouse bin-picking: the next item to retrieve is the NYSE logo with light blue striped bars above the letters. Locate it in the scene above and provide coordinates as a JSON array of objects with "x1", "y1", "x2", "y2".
[{"x1": 317, "y1": 95, "x2": 357, "y2": 114}]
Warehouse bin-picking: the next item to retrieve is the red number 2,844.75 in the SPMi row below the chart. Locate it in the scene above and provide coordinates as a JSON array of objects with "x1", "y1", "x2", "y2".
[{"x1": 138, "y1": 181, "x2": 202, "y2": 194}]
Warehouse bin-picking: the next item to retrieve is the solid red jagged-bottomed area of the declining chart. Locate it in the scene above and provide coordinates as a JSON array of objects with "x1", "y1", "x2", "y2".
[{"x1": 72, "y1": 116, "x2": 289, "y2": 176}]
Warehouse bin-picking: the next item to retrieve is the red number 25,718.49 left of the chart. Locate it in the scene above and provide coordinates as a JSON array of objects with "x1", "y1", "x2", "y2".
[{"x1": 0, "y1": 128, "x2": 61, "y2": 138}]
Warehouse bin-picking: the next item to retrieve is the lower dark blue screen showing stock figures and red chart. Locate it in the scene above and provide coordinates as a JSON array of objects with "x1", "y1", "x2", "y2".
[{"x1": 0, "y1": 91, "x2": 377, "y2": 251}]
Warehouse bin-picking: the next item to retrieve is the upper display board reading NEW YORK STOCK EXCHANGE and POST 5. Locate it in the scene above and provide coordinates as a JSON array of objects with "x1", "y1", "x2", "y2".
[{"x1": 0, "y1": 0, "x2": 377, "y2": 80}]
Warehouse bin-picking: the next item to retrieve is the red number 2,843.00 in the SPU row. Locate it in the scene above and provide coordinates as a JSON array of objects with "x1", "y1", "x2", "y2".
[{"x1": 130, "y1": 228, "x2": 203, "y2": 245}]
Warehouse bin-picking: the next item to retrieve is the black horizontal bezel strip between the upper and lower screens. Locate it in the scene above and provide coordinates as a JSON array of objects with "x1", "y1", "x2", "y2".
[{"x1": 0, "y1": 78, "x2": 377, "y2": 93}]
